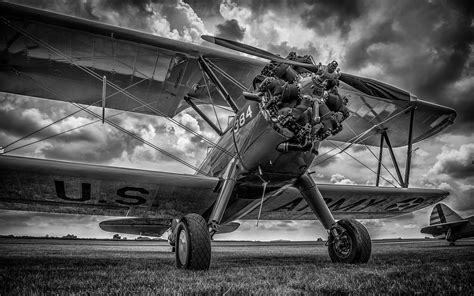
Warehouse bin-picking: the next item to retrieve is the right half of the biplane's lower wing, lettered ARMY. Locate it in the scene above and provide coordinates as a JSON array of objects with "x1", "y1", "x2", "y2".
[{"x1": 225, "y1": 184, "x2": 449, "y2": 220}]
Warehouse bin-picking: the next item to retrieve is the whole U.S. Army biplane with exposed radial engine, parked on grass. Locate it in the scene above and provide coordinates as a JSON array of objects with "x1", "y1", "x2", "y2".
[{"x1": 0, "y1": 3, "x2": 456, "y2": 270}]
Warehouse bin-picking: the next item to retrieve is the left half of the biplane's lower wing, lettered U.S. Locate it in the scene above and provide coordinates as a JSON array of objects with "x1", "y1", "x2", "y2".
[{"x1": 0, "y1": 156, "x2": 219, "y2": 219}]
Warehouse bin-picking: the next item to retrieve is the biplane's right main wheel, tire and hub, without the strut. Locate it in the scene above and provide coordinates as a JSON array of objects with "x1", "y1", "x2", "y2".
[{"x1": 328, "y1": 219, "x2": 372, "y2": 263}]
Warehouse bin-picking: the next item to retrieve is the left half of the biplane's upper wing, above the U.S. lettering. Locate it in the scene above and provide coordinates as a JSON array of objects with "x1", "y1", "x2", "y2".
[{"x1": 0, "y1": 3, "x2": 263, "y2": 116}]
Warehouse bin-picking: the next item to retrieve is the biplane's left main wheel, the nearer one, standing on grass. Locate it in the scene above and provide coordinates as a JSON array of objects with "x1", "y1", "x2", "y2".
[{"x1": 175, "y1": 214, "x2": 211, "y2": 270}]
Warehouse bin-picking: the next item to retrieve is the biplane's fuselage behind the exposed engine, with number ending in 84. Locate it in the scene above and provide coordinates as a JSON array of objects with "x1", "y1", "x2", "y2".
[{"x1": 200, "y1": 101, "x2": 315, "y2": 185}]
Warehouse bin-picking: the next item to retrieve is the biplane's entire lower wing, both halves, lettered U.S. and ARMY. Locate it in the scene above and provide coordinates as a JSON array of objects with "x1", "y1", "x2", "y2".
[{"x1": 0, "y1": 156, "x2": 449, "y2": 222}]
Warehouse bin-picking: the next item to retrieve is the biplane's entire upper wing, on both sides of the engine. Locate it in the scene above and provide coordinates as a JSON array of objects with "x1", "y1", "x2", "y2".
[{"x1": 0, "y1": 3, "x2": 456, "y2": 147}]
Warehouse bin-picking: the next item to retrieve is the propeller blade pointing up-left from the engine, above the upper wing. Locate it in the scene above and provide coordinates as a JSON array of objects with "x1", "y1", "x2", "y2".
[{"x1": 201, "y1": 35, "x2": 318, "y2": 72}]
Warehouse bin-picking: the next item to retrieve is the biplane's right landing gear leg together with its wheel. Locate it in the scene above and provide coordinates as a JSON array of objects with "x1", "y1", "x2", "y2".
[{"x1": 295, "y1": 173, "x2": 372, "y2": 263}]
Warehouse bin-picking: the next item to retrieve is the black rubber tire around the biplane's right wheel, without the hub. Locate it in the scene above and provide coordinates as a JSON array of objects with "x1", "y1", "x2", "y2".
[{"x1": 328, "y1": 219, "x2": 372, "y2": 263}]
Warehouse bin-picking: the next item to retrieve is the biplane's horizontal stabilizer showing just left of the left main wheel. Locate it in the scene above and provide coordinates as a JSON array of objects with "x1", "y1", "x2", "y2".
[{"x1": 99, "y1": 218, "x2": 171, "y2": 237}]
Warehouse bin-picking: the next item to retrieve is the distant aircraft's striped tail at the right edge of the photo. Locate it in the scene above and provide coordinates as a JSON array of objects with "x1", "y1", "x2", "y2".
[{"x1": 421, "y1": 203, "x2": 474, "y2": 246}]
